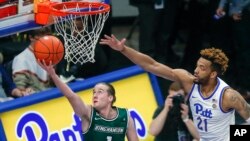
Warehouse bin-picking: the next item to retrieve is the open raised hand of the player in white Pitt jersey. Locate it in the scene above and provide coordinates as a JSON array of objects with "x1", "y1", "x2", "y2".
[{"x1": 100, "y1": 34, "x2": 126, "y2": 51}]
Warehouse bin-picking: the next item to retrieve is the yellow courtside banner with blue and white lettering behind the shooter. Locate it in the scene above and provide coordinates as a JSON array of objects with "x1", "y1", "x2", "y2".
[{"x1": 0, "y1": 65, "x2": 162, "y2": 141}]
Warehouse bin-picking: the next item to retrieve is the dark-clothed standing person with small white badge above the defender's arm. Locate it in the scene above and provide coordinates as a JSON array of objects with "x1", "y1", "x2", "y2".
[{"x1": 130, "y1": 0, "x2": 181, "y2": 64}]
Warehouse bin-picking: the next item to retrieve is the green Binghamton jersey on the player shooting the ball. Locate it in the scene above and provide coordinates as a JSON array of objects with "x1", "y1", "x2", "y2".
[{"x1": 83, "y1": 107, "x2": 129, "y2": 141}]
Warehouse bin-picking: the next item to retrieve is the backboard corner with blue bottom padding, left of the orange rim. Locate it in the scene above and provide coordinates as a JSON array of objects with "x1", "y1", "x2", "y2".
[{"x1": 0, "y1": 0, "x2": 109, "y2": 37}]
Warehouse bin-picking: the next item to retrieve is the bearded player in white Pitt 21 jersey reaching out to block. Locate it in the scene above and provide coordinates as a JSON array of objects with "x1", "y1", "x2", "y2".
[{"x1": 100, "y1": 35, "x2": 250, "y2": 141}]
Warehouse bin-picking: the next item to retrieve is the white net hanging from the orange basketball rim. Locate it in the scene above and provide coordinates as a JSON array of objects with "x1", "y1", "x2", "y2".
[{"x1": 53, "y1": 3, "x2": 109, "y2": 64}]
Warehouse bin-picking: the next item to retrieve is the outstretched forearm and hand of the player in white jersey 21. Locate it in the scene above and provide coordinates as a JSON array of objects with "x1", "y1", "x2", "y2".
[{"x1": 100, "y1": 35, "x2": 177, "y2": 81}]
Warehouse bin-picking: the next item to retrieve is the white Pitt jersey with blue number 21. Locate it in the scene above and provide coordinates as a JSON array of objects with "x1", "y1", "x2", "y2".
[{"x1": 189, "y1": 78, "x2": 235, "y2": 141}]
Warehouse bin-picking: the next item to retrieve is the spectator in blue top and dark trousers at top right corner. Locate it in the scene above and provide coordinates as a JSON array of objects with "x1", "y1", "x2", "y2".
[{"x1": 216, "y1": 0, "x2": 250, "y2": 93}]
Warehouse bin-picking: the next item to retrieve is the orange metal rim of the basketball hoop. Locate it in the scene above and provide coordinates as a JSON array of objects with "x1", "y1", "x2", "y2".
[{"x1": 50, "y1": 2, "x2": 110, "y2": 16}]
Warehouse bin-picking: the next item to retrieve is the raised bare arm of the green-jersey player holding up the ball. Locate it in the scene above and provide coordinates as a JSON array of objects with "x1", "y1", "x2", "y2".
[{"x1": 37, "y1": 60, "x2": 91, "y2": 117}]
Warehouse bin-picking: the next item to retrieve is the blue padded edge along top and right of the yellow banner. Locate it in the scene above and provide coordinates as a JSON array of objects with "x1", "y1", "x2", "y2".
[{"x1": 0, "y1": 66, "x2": 162, "y2": 112}]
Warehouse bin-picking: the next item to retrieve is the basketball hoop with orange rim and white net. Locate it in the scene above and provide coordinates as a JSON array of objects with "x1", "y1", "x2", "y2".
[{"x1": 50, "y1": 1, "x2": 110, "y2": 64}]
